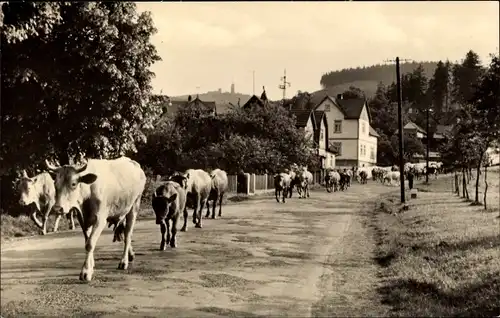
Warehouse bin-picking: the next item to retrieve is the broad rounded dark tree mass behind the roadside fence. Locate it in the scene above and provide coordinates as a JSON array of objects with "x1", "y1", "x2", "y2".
[{"x1": 137, "y1": 103, "x2": 318, "y2": 174}]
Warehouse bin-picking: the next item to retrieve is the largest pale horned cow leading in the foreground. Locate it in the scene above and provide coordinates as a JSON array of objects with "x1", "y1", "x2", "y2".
[{"x1": 45, "y1": 157, "x2": 146, "y2": 281}]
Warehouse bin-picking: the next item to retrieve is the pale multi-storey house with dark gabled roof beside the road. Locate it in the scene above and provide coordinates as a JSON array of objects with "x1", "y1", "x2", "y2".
[{"x1": 313, "y1": 94, "x2": 379, "y2": 167}]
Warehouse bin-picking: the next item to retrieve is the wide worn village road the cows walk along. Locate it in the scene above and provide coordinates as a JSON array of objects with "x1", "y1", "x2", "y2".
[{"x1": 1, "y1": 183, "x2": 394, "y2": 317}]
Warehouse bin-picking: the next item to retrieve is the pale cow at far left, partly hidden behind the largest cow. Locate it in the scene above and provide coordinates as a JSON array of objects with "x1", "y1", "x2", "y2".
[{"x1": 19, "y1": 170, "x2": 75, "y2": 235}]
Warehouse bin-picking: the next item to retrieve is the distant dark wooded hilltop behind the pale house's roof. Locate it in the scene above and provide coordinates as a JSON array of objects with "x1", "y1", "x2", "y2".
[{"x1": 320, "y1": 62, "x2": 437, "y2": 96}]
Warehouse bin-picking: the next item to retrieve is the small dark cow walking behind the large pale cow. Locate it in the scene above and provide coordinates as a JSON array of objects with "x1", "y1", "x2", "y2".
[{"x1": 151, "y1": 181, "x2": 187, "y2": 251}]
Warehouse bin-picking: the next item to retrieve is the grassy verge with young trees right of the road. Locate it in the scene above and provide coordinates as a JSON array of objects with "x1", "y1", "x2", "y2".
[{"x1": 371, "y1": 167, "x2": 500, "y2": 317}]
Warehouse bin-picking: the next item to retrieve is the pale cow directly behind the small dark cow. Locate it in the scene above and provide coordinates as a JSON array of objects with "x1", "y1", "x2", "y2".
[{"x1": 170, "y1": 169, "x2": 212, "y2": 232}]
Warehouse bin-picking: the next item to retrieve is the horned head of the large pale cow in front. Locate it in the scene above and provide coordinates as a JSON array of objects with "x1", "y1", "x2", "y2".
[{"x1": 45, "y1": 160, "x2": 97, "y2": 214}]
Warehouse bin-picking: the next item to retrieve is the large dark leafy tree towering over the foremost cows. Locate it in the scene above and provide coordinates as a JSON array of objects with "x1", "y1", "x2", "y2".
[{"x1": 1, "y1": 2, "x2": 160, "y2": 168}]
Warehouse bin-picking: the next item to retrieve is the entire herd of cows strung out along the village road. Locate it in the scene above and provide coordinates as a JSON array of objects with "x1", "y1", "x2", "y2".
[{"x1": 19, "y1": 157, "x2": 441, "y2": 281}]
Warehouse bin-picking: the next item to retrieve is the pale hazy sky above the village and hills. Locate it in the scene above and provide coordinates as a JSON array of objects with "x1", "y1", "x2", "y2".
[{"x1": 137, "y1": 1, "x2": 500, "y2": 99}]
